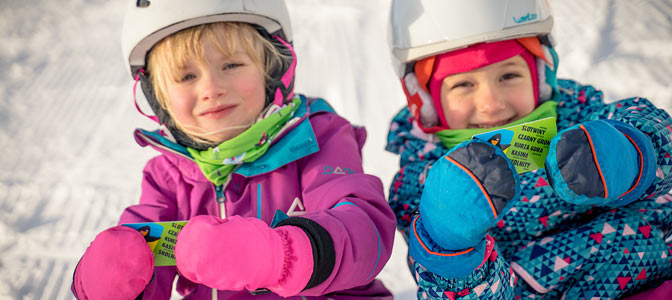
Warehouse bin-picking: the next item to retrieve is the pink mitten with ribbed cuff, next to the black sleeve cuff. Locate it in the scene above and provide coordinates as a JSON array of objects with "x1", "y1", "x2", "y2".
[{"x1": 175, "y1": 216, "x2": 313, "y2": 297}]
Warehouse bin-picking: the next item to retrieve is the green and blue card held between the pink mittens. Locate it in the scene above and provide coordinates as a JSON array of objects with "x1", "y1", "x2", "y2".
[{"x1": 121, "y1": 221, "x2": 187, "y2": 267}]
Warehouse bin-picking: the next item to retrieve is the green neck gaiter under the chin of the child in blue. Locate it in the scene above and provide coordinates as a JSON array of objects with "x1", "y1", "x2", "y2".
[{"x1": 435, "y1": 100, "x2": 558, "y2": 149}]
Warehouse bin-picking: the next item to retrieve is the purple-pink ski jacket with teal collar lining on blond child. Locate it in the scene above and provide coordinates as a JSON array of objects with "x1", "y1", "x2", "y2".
[{"x1": 119, "y1": 97, "x2": 395, "y2": 299}]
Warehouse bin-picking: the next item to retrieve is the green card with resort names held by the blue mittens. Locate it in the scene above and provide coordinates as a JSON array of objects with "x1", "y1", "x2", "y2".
[{"x1": 473, "y1": 117, "x2": 557, "y2": 174}]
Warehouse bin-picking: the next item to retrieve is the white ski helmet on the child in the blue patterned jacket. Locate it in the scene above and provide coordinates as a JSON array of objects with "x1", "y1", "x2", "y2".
[{"x1": 390, "y1": 0, "x2": 553, "y2": 77}]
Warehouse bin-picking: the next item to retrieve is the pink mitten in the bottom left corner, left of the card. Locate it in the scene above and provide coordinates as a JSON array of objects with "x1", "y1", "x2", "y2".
[{"x1": 72, "y1": 226, "x2": 154, "y2": 300}]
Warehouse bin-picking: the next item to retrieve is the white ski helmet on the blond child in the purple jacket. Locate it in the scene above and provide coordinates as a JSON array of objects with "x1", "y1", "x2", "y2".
[{"x1": 121, "y1": 0, "x2": 292, "y2": 76}]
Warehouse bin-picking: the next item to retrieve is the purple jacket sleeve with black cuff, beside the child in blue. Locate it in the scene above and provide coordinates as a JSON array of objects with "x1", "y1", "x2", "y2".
[{"x1": 278, "y1": 112, "x2": 394, "y2": 296}]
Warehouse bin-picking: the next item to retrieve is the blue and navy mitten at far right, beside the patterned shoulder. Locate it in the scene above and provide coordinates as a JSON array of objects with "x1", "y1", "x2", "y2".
[{"x1": 546, "y1": 120, "x2": 656, "y2": 207}]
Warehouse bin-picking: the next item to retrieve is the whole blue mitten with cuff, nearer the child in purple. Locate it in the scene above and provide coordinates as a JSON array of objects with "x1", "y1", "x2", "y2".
[{"x1": 409, "y1": 140, "x2": 520, "y2": 278}]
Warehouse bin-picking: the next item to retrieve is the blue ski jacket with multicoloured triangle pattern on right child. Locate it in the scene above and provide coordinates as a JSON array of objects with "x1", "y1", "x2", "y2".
[{"x1": 386, "y1": 80, "x2": 672, "y2": 299}]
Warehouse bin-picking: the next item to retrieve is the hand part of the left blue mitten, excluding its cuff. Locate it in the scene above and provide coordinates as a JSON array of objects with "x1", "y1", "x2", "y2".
[{"x1": 420, "y1": 140, "x2": 520, "y2": 250}]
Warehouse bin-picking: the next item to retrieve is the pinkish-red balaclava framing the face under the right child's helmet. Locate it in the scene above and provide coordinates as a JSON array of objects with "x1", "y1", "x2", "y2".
[{"x1": 427, "y1": 40, "x2": 539, "y2": 129}]
